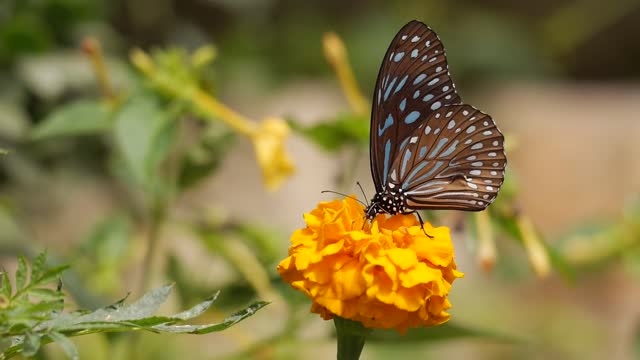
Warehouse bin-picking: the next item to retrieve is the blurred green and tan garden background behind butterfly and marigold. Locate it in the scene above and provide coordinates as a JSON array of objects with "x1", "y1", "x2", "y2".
[{"x1": 0, "y1": 0, "x2": 640, "y2": 360}]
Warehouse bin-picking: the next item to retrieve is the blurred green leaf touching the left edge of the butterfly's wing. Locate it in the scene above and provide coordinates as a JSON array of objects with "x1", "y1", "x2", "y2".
[{"x1": 288, "y1": 114, "x2": 369, "y2": 152}]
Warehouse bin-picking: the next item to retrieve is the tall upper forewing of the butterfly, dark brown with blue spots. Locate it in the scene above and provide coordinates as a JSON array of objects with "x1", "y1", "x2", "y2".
[{"x1": 369, "y1": 21, "x2": 460, "y2": 192}]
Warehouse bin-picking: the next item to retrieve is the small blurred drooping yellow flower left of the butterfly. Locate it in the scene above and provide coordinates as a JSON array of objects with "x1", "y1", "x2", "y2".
[{"x1": 251, "y1": 118, "x2": 294, "y2": 190}]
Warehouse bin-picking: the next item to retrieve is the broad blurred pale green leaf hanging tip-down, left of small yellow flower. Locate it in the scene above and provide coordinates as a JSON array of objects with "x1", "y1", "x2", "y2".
[{"x1": 114, "y1": 97, "x2": 175, "y2": 186}]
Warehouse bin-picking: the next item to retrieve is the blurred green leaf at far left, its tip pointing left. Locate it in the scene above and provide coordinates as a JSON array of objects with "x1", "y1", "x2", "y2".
[{"x1": 31, "y1": 100, "x2": 111, "y2": 140}]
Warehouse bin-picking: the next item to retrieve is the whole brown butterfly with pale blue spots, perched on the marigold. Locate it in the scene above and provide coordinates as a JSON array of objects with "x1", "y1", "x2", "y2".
[{"x1": 365, "y1": 21, "x2": 507, "y2": 219}]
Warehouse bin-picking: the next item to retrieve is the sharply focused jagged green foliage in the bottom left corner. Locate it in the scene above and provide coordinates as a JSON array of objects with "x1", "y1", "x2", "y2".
[{"x1": 0, "y1": 253, "x2": 267, "y2": 359}]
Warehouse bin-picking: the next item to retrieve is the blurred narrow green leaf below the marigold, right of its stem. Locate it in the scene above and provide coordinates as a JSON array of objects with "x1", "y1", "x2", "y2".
[{"x1": 367, "y1": 322, "x2": 524, "y2": 344}]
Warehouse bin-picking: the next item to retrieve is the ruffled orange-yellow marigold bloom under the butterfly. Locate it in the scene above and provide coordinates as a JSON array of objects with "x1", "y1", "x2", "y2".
[{"x1": 278, "y1": 198, "x2": 463, "y2": 333}]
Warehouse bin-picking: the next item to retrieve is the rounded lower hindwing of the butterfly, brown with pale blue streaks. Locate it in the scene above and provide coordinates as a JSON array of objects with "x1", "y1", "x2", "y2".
[{"x1": 389, "y1": 105, "x2": 507, "y2": 211}]
